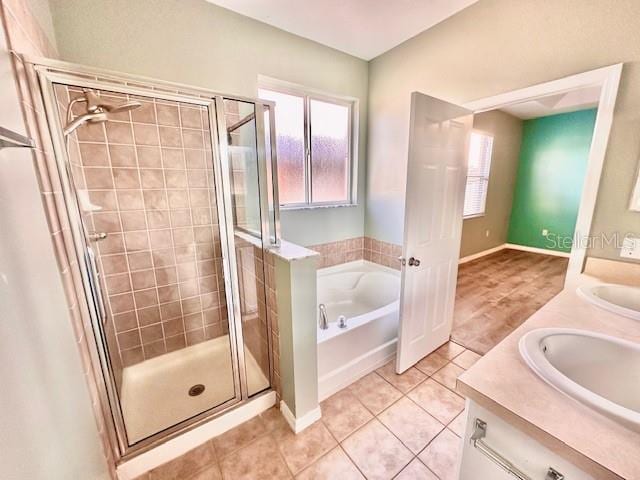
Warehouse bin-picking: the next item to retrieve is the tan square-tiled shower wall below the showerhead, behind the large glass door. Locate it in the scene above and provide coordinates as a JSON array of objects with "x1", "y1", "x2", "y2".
[{"x1": 57, "y1": 87, "x2": 228, "y2": 367}]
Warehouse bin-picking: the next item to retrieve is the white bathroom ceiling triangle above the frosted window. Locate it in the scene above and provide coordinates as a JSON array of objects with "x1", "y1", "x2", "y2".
[{"x1": 202, "y1": 0, "x2": 478, "y2": 60}]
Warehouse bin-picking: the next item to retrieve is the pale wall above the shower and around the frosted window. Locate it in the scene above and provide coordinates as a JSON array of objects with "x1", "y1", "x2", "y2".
[{"x1": 51, "y1": 0, "x2": 368, "y2": 245}]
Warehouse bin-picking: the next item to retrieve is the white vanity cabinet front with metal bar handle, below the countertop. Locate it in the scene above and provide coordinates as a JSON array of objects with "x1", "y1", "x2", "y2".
[{"x1": 458, "y1": 400, "x2": 596, "y2": 480}]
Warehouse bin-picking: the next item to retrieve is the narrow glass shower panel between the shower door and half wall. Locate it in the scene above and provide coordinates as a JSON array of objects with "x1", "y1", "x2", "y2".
[{"x1": 219, "y1": 98, "x2": 272, "y2": 396}]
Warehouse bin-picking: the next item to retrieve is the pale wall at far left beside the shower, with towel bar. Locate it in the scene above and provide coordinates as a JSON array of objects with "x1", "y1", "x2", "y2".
[{"x1": 0, "y1": 0, "x2": 110, "y2": 480}]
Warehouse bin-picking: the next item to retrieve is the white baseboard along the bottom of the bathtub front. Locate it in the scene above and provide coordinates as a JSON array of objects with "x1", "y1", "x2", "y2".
[{"x1": 318, "y1": 338, "x2": 398, "y2": 401}]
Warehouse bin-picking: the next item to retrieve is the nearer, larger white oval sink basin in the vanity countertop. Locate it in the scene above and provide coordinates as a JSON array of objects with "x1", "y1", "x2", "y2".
[{"x1": 520, "y1": 328, "x2": 640, "y2": 432}]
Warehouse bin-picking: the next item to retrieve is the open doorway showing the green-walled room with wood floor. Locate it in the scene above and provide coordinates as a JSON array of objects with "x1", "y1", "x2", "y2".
[{"x1": 451, "y1": 86, "x2": 601, "y2": 354}]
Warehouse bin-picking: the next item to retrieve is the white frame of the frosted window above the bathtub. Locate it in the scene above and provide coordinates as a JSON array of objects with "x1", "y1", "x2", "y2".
[{"x1": 256, "y1": 75, "x2": 360, "y2": 210}]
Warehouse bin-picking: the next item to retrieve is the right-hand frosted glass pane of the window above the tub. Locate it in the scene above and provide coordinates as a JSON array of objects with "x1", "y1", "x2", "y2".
[{"x1": 310, "y1": 100, "x2": 349, "y2": 202}]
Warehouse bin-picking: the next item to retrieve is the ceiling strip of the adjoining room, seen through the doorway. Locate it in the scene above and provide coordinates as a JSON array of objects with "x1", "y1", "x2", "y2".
[{"x1": 500, "y1": 86, "x2": 600, "y2": 120}]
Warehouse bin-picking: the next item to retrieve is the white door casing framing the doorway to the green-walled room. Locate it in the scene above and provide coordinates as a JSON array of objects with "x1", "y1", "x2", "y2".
[{"x1": 463, "y1": 63, "x2": 622, "y2": 286}]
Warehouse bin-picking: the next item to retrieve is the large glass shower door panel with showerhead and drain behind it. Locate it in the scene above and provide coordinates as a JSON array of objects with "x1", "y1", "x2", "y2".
[{"x1": 54, "y1": 84, "x2": 241, "y2": 446}]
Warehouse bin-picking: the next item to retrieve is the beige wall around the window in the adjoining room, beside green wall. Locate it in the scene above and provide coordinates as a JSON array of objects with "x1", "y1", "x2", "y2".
[{"x1": 460, "y1": 110, "x2": 522, "y2": 257}]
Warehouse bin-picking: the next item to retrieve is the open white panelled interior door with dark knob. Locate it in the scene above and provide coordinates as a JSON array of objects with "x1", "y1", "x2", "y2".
[{"x1": 396, "y1": 92, "x2": 473, "y2": 373}]
